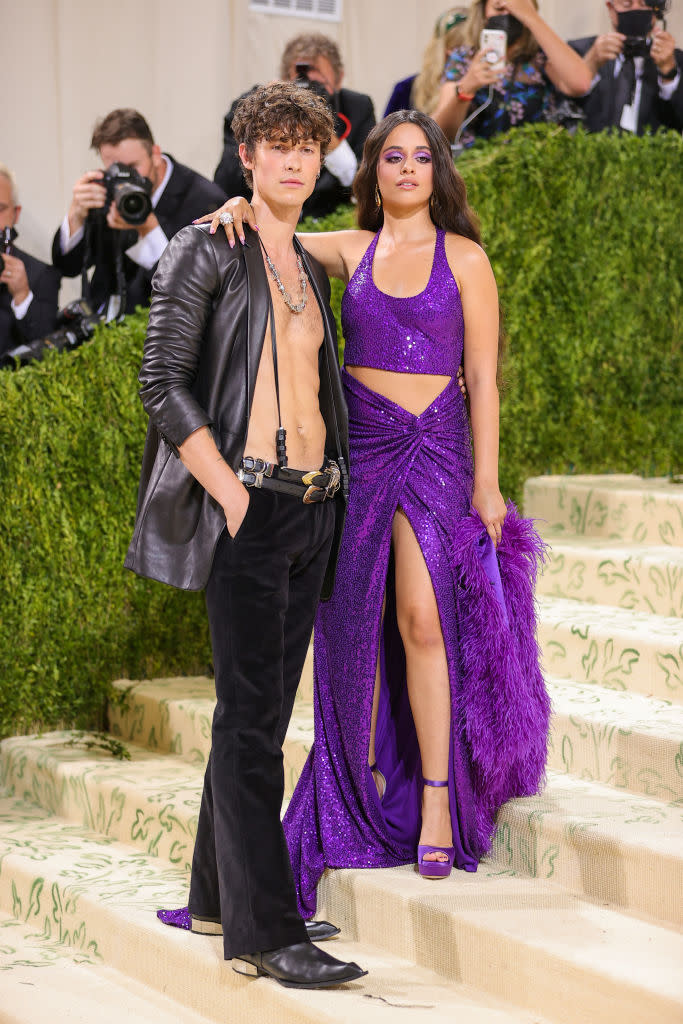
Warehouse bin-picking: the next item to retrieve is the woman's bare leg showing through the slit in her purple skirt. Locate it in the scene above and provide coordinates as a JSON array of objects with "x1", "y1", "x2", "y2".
[{"x1": 392, "y1": 509, "x2": 453, "y2": 861}]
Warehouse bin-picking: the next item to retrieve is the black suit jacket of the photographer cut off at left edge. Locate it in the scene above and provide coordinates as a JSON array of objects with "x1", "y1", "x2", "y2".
[{"x1": 0, "y1": 246, "x2": 61, "y2": 355}]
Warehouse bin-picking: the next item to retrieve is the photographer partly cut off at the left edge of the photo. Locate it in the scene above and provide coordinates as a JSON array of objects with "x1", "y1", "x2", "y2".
[{"x1": 0, "y1": 164, "x2": 59, "y2": 356}]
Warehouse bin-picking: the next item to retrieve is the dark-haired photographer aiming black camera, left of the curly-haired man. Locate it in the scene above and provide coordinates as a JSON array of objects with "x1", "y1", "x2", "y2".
[{"x1": 52, "y1": 109, "x2": 225, "y2": 319}]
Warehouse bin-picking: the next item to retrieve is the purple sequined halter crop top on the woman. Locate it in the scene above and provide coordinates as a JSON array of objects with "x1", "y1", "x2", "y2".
[{"x1": 341, "y1": 230, "x2": 465, "y2": 377}]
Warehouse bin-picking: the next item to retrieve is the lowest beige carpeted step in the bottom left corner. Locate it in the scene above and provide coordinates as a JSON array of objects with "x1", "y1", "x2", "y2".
[{"x1": 0, "y1": 913, "x2": 216, "y2": 1024}]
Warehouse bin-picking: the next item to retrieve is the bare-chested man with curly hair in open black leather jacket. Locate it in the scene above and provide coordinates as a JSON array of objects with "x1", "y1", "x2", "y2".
[{"x1": 126, "y1": 83, "x2": 365, "y2": 988}]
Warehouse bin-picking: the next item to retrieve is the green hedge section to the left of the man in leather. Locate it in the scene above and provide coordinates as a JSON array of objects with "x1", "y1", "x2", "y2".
[{"x1": 0, "y1": 314, "x2": 210, "y2": 734}]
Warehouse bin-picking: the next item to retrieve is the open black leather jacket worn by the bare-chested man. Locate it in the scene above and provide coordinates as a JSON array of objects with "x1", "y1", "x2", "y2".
[{"x1": 125, "y1": 224, "x2": 348, "y2": 598}]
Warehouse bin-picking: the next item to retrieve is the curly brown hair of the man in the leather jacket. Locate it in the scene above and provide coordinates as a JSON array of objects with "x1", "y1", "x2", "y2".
[{"x1": 232, "y1": 82, "x2": 335, "y2": 188}]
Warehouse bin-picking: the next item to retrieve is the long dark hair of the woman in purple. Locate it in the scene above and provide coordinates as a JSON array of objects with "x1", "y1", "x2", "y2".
[{"x1": 353, "y1": 111, "x2": 507, "y2": 385}]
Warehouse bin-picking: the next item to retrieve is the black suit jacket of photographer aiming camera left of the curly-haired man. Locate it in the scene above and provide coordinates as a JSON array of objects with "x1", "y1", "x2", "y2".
[{"x1": 52, "y1": 157, "x2": 227, "y2": 313}]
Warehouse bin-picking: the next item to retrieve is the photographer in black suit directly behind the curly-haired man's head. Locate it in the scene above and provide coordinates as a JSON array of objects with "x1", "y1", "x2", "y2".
[{"x1": 214, "y1": 33, "x2": 375, "y2": 217}]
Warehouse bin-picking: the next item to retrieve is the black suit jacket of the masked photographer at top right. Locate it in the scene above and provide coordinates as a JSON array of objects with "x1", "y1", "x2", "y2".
[{"x1": 569, "y1": 36, "x2": 683, "y2": 135}]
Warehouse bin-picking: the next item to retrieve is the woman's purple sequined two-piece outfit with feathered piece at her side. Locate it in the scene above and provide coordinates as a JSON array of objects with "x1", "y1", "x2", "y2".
[{"x1": 285, "y1": 231, "x2": 549, "y2": 918}]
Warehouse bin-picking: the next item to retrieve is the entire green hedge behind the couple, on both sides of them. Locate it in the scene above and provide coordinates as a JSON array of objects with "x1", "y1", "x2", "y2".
[{"x1": 0, "y1": 128, "x2": 683, "y2": 734}]
